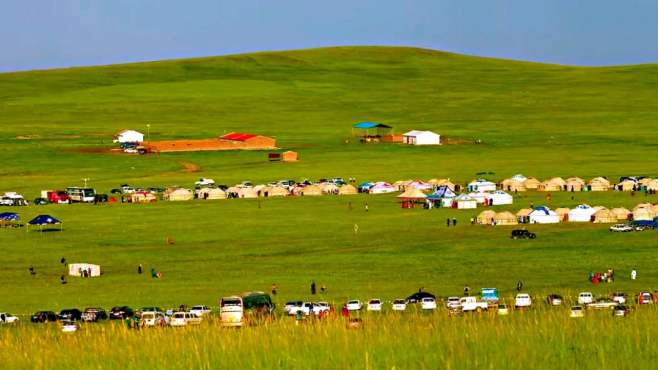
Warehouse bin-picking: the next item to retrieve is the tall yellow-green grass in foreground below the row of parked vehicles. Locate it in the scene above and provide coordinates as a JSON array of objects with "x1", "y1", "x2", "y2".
[{"x1": 0, "y1": 309, "x2": 657, "y2": 369}]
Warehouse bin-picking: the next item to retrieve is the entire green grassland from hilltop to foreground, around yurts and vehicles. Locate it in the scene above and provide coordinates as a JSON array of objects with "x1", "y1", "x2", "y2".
[{"x1": 0, "y1": 48, "x2": 658, "y2": 368}]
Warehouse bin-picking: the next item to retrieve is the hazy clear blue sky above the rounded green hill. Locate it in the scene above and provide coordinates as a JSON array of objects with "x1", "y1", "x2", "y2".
[{"x1": 0, "y1": 0, "x2": 658, "y2": 71}]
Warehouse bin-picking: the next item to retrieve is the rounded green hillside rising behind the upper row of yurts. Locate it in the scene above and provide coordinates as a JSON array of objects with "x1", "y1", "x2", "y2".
[{"x1": 0, "y1": 47, "x2": 658, "y2": 190}]
